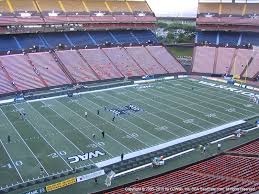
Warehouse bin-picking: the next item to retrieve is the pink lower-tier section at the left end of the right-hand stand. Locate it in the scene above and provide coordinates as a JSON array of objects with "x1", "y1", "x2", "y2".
[{"x1": 192, "y1": 46, "x2": 216, "y2": 74}]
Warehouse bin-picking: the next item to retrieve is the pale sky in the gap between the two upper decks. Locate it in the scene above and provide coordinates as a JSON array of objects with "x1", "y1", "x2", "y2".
[{"x1": 147, "y1": 0, "x2": 198, "y2": 17}]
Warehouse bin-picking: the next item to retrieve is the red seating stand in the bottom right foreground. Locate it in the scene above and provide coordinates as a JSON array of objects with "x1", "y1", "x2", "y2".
[{"x1": 106, "y1": 140, "x2": 259, "y2": 194}]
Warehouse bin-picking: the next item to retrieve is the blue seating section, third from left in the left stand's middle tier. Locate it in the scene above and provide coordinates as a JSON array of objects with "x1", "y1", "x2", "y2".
[{"x1": 40, "y1": 32, "x2": 73, "y2": 48}]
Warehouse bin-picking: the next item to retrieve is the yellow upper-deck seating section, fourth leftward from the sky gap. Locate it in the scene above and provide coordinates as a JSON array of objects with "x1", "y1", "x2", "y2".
[{"x1": 61, "y1": 0, "x2": 87, "y2": 13}]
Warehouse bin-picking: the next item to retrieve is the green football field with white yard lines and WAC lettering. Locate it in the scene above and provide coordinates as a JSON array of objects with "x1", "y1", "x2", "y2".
[{"x1": 0, "y1": 78, "x2": 259, "y2": 188}]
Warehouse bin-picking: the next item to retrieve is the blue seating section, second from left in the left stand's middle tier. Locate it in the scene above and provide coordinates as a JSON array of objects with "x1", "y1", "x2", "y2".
[{"x1": 15, "y1": 34, "x2": 47, "y2": 49}]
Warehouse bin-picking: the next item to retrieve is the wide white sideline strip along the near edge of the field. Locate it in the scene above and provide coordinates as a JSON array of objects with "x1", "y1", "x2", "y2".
[{"x1": 96, "y1": 120, "x2": 245, "y2": 168}]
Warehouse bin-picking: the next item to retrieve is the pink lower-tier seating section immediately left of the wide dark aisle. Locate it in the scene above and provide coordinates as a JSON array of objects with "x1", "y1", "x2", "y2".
[{"x1": 28, "y1": 52, "x2": 70, "y2": 86}]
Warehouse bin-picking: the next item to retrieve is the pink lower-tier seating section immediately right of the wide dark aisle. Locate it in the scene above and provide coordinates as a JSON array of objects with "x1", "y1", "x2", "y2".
[{"x1": 56, "y1": 50, "x2": 98, "y2": 82}]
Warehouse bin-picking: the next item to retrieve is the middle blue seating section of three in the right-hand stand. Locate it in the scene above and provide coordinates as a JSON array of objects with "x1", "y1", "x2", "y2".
[{"x1": 219, "y1": 32, "x2": 240, "y2": 46}]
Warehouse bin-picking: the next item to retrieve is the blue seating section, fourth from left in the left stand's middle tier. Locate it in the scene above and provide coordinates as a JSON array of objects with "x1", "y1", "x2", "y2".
[{"x1": 65, "y1": 32, "x2": 95, "y2": 46}]
